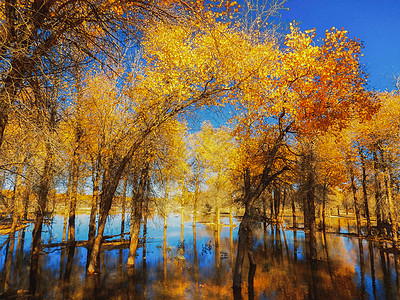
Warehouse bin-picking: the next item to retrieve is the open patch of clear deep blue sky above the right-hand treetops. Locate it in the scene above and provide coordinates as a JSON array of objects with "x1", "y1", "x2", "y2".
[{"x1": 282, "y1": 0, "x2": 400, "y2": 90}]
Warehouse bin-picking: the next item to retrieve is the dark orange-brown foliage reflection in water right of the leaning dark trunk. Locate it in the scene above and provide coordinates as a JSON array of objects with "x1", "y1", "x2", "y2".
[{"x1": 250, "y1": 230, "x2": 358, "y2": 299}]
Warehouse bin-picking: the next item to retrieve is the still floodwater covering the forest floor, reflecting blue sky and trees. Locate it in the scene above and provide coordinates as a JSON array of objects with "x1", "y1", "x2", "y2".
[{"x1": 0, "y1": 214, "x2": 400, "y2": 300}]
